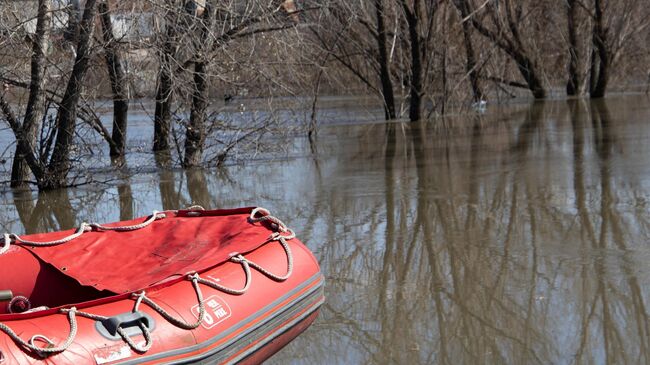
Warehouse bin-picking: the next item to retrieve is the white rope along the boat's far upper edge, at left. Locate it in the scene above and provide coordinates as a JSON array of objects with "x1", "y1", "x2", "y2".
[{"x1": 0, "y1": 210, "x2": 166, "y2": 255}]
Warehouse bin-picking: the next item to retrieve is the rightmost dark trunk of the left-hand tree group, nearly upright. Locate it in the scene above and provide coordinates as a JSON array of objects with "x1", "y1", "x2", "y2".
[{"x1": 183, "y1": 1, "x2": 215, "y2": 167}]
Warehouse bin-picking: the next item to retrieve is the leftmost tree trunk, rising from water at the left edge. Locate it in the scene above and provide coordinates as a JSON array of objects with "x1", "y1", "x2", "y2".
[{"x1": 11, "y1": 0, "x2": 52, "y2": 188}]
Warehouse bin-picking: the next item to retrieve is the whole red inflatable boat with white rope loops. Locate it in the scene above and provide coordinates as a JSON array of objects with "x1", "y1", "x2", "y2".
[{"x1": 0, "y1": 207, "x2": 324, "y2": 365}]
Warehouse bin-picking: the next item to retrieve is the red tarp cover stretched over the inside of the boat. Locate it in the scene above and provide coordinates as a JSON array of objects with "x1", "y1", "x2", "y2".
[{"x1": 22, "y1": 208, "x2": 272, "y2": 293}]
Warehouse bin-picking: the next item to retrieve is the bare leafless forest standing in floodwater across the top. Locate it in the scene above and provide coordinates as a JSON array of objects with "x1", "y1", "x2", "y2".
[{"x1": 0, "y1": 0, "x2": 650, "y2": 190}]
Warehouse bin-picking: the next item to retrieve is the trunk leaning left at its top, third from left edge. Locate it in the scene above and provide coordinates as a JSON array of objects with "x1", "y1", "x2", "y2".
[{"x1": 99, "y1": 0, "x2": 129, "y2": 159}]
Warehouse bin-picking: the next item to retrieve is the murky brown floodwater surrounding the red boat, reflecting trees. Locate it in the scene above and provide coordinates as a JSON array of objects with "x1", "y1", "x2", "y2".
[{"x1": 0, "y1": 96, "x2": 650, "y2": 364}]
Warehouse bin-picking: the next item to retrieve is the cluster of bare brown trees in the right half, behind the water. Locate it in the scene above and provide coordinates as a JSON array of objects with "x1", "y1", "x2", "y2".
[{"x1": 313, "y1": 0, "x2": 650, "y2": 121}]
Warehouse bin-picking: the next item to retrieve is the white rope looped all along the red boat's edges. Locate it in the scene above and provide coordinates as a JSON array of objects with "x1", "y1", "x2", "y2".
[{"x1": 0, "y1": 206, "x2": 296, "y2": 356}]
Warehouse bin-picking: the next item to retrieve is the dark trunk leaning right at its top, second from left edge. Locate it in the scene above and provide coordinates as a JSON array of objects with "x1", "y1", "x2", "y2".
[{"x1": 45, "y1": 0, "x2": 96, "y2": 189}]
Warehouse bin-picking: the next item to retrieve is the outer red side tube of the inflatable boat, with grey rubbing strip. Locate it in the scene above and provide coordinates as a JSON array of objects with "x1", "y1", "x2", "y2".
[{"x1": 0, "y1": 209, "x2": 324, "y2": 365}]
